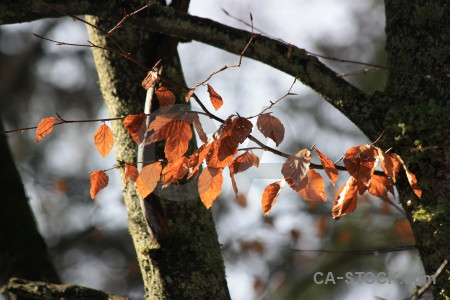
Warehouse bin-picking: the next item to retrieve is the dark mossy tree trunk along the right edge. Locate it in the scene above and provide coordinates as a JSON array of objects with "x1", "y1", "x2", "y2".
[{"x1": 378, "y1": 0, "x2": 450, "y2": 299}]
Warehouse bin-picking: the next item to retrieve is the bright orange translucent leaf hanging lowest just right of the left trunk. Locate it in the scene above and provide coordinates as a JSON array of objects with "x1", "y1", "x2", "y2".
[{"x1": 198, "y1": 167, "x2": 223, "y2": 208}]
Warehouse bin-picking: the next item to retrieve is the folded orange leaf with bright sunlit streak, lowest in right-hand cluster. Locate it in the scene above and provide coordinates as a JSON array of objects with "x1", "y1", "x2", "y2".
[{"x1": 332, "y1": 176, "x2": 358, "y2": 220}]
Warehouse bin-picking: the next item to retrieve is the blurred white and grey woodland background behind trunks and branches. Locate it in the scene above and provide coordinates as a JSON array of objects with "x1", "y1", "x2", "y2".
[{"x1": 0, "y1": 0, "x2": 423, "y2": 300}]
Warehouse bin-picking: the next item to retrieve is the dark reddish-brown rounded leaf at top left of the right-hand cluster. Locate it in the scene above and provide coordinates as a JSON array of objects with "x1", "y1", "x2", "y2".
[{"x1": 344, "y1": 144, "x2": 377, "y2": 183}]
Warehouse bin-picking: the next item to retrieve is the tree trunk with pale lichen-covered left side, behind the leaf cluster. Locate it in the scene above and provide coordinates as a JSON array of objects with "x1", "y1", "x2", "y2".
[{"x1": 87, "y1": 1, "x2": 229, "y2": 299}]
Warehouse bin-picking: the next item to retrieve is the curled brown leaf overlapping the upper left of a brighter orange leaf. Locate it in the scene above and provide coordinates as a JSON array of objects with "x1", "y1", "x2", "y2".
[{"x1": 281, "y1": 149, "x2": 311, "y2": 192}]
